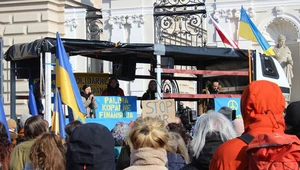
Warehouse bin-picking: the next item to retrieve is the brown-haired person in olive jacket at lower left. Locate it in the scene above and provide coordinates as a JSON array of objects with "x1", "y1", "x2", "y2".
[{"x1": 9, "y1": 116, "x2": 48, "y2": 170}]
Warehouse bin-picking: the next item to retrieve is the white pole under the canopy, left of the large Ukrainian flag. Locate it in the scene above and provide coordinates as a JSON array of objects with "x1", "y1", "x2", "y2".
[{"x1": 44, "y1": 52, "x2": 52, "y2": 126}]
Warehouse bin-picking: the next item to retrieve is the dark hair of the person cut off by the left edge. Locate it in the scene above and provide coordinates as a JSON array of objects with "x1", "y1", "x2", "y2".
[{"x1": 0, "y1": 122, "x2": 12, "y2": 162}]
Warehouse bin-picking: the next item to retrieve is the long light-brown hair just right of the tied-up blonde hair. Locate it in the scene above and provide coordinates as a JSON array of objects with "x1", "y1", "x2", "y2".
[{"x1": 167, "y1": 132, "x2": 190, "y2": 164}]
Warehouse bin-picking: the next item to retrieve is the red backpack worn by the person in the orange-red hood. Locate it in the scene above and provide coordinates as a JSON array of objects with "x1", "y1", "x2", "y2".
[{"x1": 238, "y1": 133, "x2": 300, "y2": 170}]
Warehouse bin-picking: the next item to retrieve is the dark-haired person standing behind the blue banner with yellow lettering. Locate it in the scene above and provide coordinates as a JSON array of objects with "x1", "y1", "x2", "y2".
[{"x1": 101, "y1": 77, "x2": 124, "y2": 96}]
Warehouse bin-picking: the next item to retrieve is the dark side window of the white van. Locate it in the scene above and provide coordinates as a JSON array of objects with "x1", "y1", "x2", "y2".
[{"x1": 260, "y1": 54, "x2": 279, "y2": 79}]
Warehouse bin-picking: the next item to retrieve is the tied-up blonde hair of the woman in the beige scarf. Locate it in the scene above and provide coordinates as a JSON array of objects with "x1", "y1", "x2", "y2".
[{"x1": 128, "y1": 117, "x2": 169, "y2": 150}]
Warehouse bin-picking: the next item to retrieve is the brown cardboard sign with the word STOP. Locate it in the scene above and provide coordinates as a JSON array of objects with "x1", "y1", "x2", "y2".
[{"x1": 142, "y1": 99, "x2": 176, "y2": 123}]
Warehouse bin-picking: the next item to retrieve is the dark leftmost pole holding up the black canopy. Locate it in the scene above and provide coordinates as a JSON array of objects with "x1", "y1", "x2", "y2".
[{"x1": 10, "y1": 61, "x2": 18, "y2": 121}]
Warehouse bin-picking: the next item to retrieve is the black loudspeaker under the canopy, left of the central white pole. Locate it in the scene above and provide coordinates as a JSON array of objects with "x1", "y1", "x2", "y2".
[{"x1": 113, "y1": 54, "x2": 137, "y2": 81}]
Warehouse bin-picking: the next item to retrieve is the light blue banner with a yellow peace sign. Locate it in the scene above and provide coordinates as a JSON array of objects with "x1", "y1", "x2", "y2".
[{"x1": 214, "y1": 98, "x2": 242, "y2": 118}]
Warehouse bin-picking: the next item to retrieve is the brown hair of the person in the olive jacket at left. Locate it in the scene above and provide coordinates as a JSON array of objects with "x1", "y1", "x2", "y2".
[{"x1": 24, "y1": 116, "x2": 48, "y2": 139}]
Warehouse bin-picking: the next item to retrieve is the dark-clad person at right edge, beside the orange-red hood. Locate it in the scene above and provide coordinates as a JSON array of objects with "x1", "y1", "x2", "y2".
[{"x1": 284, "y1": 101, "x2": 300, "y2": 139}]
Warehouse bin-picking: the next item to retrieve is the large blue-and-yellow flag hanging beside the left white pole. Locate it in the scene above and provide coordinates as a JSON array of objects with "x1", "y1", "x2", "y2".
[{"x1": 56, "y1": 33, "x2": 86, "y2": 122}]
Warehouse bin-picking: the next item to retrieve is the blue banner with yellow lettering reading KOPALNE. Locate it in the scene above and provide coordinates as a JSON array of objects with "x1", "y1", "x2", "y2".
[{"x1": 95, "y1": 96, "x2": 137, "y2": 120}]
